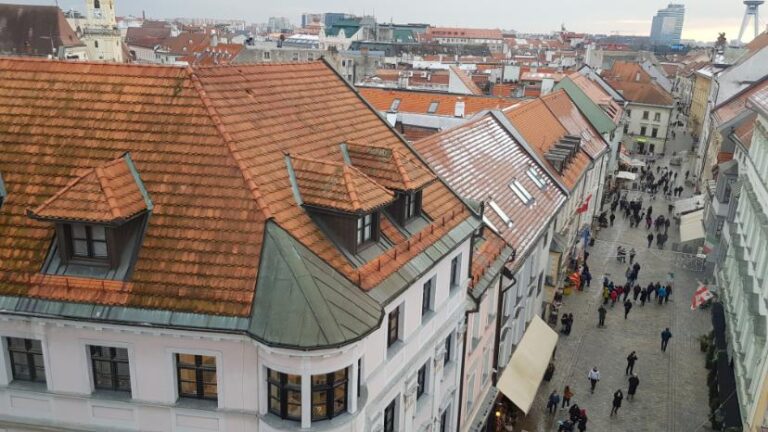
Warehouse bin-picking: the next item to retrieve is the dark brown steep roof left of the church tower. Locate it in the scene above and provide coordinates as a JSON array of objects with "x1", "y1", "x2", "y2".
[{"x1": 0, "y1": 4, "x2": 83, "y2": 57}]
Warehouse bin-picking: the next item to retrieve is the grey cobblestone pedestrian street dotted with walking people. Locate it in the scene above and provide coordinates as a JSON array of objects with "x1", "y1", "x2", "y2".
[{"x1": 526, "y1": 115, "x2": 711, "y2": 432}]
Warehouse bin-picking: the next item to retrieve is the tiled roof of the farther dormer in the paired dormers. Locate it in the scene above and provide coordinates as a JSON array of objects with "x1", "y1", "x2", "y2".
[{"x1": 345, "y1": 143, "x2": 437, "y2": 192}]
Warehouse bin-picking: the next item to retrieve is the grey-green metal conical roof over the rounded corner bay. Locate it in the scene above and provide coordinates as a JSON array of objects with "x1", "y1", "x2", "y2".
[{"x1": 248, "y1": 222, "x2": 384, "y2": 349}]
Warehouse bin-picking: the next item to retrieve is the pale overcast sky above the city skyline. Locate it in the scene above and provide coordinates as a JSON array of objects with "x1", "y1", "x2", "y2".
[{"x1": 12, "y1": 0, "x2": 768, "y2": 41}]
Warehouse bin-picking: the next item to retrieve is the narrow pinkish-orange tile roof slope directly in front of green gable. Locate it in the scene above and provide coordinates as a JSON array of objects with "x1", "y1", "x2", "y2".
[{"x1": 541, "y1": 90, "x2": 608, "y2": 159}]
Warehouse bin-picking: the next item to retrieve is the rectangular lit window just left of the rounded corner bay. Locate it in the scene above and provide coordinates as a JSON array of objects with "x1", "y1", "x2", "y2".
[{"x1": 176, "y1": 354, "x2": 219, "y2": 400}]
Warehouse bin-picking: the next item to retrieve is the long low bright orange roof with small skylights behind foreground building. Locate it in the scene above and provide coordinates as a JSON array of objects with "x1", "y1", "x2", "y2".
[{"x1": 357, "y1": 87, "x2": 519, "y2": 117}]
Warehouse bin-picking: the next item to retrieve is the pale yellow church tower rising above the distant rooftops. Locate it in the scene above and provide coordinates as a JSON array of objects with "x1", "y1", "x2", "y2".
[{"x1": 77, "y1": 0, "x2": 125, "y2": 63}]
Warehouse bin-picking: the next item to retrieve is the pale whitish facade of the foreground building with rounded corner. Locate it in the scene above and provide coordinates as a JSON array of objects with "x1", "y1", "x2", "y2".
[{"x1": 0, "y1": 239, "x2": 470, "y2": 432}]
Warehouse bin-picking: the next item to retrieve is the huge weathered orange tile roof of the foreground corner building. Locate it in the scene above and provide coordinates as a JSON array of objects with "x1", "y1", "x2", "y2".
[{"x1": 0, "y1": 58, "x2": 473, "y2": 316}]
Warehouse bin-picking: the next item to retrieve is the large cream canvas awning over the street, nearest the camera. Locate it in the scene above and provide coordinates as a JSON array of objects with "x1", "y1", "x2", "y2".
[{"x1": 496, "y1": 315, "x2": 557, "y2": 414}]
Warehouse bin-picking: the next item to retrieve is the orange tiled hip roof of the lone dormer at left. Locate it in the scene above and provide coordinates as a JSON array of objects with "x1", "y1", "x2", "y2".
[{"x1": 28, "y1": 155, "x2": 151, "y2": 223}]
